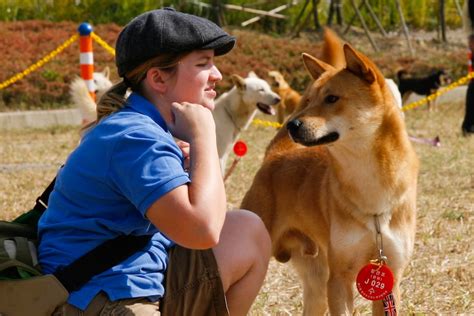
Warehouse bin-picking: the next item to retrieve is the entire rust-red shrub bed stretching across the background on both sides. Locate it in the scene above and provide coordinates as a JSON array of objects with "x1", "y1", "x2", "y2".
[{"x1": 0, "y1": 21, "x2": 465, "y2": 111}]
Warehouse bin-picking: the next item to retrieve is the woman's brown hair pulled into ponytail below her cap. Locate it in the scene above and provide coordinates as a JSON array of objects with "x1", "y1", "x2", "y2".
[{"x1": 84, "y1": 52, "x2": 189, "y2": 129}]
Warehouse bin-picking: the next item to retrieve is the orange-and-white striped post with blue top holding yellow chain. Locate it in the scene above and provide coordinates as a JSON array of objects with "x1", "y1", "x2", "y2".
[{"x1": 77, "y1": 22, "x2": 95, "y2": 101}]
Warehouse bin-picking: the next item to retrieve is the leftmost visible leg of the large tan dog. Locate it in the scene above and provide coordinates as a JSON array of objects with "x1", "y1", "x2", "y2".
[{"x1": 291, "y1": 252, "x2": 329, "y2": 316}]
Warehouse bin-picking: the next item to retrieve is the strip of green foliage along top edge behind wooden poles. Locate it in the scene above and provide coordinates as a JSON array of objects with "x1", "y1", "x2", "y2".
[{"x1": 0, "y1": 0, "x2": 461, "y2": 30}]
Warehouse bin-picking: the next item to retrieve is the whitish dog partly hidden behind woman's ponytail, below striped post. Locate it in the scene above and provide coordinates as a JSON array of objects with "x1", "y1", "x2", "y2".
[{"x1": 69, "y1": 67, "x2": 112, "y2": 125}]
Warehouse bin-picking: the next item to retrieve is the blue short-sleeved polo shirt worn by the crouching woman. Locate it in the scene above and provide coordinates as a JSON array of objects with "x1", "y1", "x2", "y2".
[{"x1": 38, "y1": 93, "x2": 190, "y2": 310}]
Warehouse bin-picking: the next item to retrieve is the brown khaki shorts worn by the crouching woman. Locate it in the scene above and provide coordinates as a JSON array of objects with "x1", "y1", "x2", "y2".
[{"x1": 53, "y1": 246, "x2": 229, "y2": 316}]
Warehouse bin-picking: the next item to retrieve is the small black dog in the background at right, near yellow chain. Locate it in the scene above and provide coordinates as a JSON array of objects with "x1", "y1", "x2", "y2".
[{"x1": 397, "y1": 69, "x2": 451, "y2": 111}]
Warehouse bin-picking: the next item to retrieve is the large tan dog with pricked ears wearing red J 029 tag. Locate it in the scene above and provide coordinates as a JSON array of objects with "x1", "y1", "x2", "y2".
[{"x1": 241, "y1": 32, "x2": 419, "y2": 315}]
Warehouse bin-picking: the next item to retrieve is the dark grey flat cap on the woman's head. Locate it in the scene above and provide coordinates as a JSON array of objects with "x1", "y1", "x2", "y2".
[{"x1": 115, "y1": 8, "x2": 235, "y2": 77}]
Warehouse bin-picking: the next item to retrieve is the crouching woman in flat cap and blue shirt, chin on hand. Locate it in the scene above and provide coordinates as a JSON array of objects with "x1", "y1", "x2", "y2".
[{"x1": 39, "y1": 8, "x2": 270, "y2": 315}]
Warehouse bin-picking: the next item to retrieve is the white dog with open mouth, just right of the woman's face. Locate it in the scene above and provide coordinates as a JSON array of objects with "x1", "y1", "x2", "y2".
[{"x1": 212, "y1": 71, "x2": 280, "y2": 174}]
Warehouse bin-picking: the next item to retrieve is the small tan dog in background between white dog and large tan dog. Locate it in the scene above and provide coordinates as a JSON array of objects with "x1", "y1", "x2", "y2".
[{"x1": 268, "y1": 70, "x2": 301, "y2": 124}]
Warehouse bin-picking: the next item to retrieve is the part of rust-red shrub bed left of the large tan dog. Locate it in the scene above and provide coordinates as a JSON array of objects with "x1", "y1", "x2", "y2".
[{"x1": 0, "y1": 21, "x2": 322, "y2": 111}]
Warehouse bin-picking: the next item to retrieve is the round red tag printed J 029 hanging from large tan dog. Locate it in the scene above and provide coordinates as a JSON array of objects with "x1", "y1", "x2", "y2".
[{"x1": 356, "y1": 263, "x2": 393, "y2": 301}]
